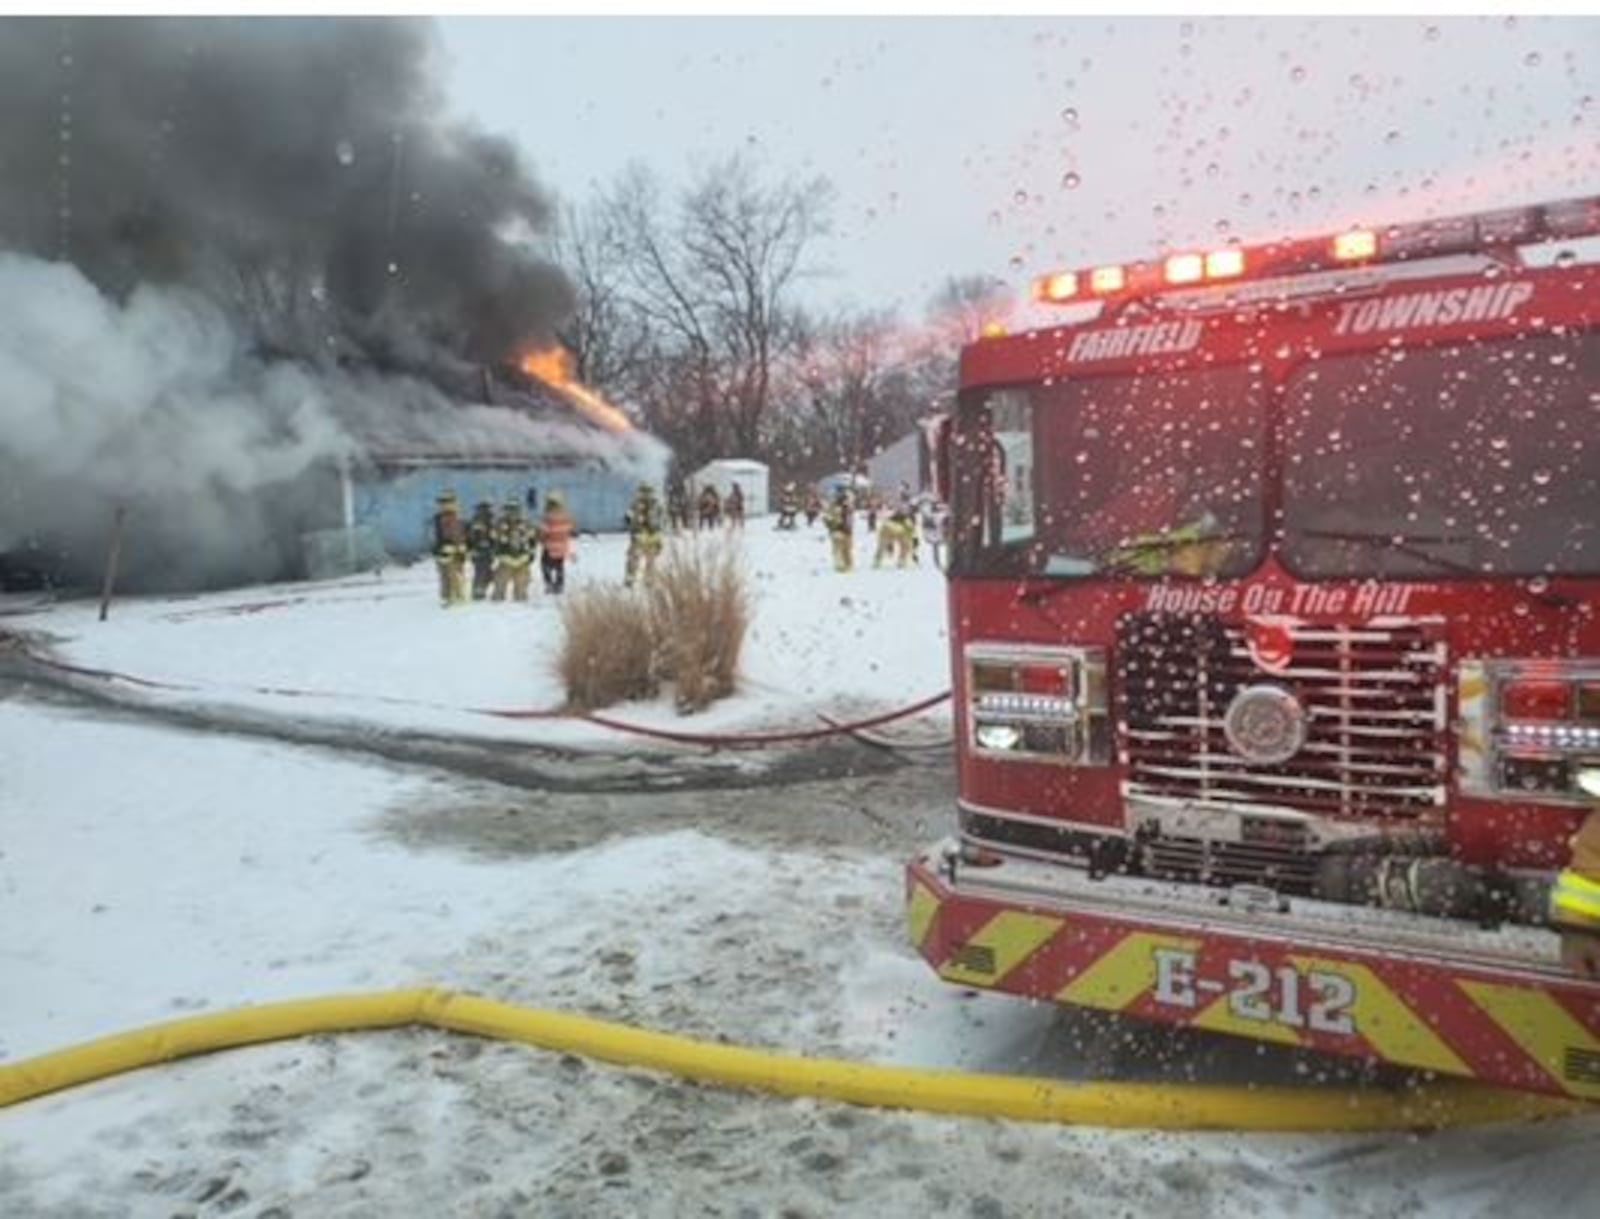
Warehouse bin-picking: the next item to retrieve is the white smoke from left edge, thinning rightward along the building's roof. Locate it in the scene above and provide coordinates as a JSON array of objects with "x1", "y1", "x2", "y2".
[{"x1": 0, "y1": 251, "x2": 666, "y2": 587}]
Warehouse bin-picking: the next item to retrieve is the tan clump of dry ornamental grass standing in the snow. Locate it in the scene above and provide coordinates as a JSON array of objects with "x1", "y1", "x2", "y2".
[{"x1": 557, "y1": 538, "x2": 750, "y2": 713}]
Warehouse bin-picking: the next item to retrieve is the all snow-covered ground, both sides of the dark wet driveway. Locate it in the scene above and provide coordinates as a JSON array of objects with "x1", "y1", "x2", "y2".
[{"x1": 0, "y1": 530, "x2": 1600, "y2": 1219}]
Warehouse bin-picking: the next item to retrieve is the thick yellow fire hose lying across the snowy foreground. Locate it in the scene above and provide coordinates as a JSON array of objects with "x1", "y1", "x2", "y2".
[{"x1": 0, "y1": 990, "x2": 1586, "y2": 1133}]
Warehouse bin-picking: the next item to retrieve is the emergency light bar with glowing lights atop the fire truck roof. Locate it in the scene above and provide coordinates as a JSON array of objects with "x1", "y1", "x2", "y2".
[{"x1": 1034, "y1": 195, "x2": 1600, "y2": 304}]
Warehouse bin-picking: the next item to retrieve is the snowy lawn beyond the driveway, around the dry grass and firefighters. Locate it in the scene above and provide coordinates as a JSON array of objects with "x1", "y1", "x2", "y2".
[{"x1": 6, "y1": 518, "x2": 949, "y2": 749}]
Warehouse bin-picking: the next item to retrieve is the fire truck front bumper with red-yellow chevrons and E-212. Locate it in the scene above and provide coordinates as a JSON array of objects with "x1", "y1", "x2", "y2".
[{"x1": 906, "y1": 838, "x2": 1600, "y2": 1101}]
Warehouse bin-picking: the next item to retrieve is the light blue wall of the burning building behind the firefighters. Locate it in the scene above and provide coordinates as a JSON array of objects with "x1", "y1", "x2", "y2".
[{"x1": 354, "y1": 464, "x2": 659, "y2": 558}]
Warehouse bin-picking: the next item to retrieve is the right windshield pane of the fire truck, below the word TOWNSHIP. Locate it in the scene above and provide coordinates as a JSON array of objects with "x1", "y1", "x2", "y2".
[{"x1": 1283, "y1": 334, "x2": 1600, "y2": 579}]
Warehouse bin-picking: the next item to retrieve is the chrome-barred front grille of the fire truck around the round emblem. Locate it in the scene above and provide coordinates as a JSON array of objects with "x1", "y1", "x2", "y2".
[{"x1": 1115, "y1": 614, "x2": 1446, "y2": 819}]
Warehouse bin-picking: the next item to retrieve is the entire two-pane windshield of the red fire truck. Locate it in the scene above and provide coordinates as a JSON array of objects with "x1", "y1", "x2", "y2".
[{"x1": 952, "y1": 334, "x2": 1600, "y2": 581}]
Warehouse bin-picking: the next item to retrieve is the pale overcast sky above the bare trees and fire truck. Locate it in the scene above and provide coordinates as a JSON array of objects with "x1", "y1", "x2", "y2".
[{"x1": 440, "y1": 16, "x2": 1600, "y2": 314}]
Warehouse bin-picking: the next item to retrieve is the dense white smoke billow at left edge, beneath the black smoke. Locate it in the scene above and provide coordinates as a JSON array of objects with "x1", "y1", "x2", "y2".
[{"x1": 0, "y1": 253, "x2": 350, "y2": 584}]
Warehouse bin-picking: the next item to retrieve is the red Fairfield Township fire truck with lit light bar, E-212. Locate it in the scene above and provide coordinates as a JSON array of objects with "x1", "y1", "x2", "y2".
[{"x1": 907, "y1": 198, "x2": 1600, "y2": 1099}]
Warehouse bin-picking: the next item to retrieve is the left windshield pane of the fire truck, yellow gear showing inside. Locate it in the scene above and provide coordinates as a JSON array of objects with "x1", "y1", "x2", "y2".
[{"x1": 952, "y1": 366, "x2": 1266, "y2": 578}]
